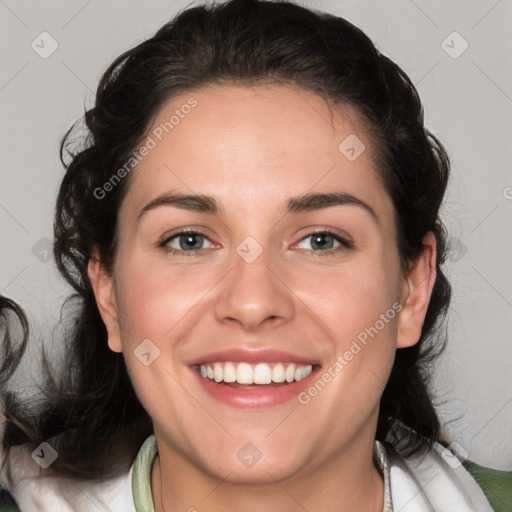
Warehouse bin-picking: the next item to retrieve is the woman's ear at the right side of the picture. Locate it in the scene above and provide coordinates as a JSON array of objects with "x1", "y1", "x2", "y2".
[{"x1": 397, "y1": 231, "x2": 436, "y2": 348}]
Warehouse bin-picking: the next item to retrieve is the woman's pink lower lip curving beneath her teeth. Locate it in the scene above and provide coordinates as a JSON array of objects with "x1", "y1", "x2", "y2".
[{"x1": 192, "y1": 367, "x2": 318, "y2": 408}]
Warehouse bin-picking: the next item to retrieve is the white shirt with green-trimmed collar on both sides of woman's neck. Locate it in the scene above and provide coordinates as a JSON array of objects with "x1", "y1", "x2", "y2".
[{"x1": 0, "y1": 435, "x2": 492, "y2": 512}]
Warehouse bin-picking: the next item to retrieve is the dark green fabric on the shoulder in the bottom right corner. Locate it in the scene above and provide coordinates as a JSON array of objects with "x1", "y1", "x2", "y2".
[{"x1": 463, "y1": 460, "x2": 512, "y2": 512}]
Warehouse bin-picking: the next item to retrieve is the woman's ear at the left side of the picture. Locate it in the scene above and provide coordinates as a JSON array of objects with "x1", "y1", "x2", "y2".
[{"x1": 87, "y1": 246, "x2": 122, "y2": 352}]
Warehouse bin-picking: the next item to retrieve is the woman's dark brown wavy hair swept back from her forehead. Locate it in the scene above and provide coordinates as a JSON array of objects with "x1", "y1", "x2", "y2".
[{"x1": 0, "y1": 0, "x2": 450, "y2": 478}]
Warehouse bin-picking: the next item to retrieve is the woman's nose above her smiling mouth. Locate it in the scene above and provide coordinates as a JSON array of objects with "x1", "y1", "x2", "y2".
[{"x1": 215, "y1": 245, "x2": 295, "y2": 332}]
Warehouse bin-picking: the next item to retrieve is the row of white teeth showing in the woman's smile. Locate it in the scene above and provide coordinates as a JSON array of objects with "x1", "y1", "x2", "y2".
[{"x1": 200, "y1": 362, "x2": 313, "y2": 384}]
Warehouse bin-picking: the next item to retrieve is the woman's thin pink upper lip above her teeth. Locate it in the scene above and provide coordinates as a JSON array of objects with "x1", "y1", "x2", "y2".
[{"x1": 189, "y1": 348, "x2": 319, "y2": 366}]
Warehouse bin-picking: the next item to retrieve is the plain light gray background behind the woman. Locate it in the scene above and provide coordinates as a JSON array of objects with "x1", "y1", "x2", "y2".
[{"x1": 0, "y1": 0, "x2": 512, "y2": 469}]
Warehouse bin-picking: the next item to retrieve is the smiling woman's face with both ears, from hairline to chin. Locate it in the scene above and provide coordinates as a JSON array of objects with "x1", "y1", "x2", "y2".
[{"x1": 90, "y1": 85, "x2": 433, "y2": 482}]
